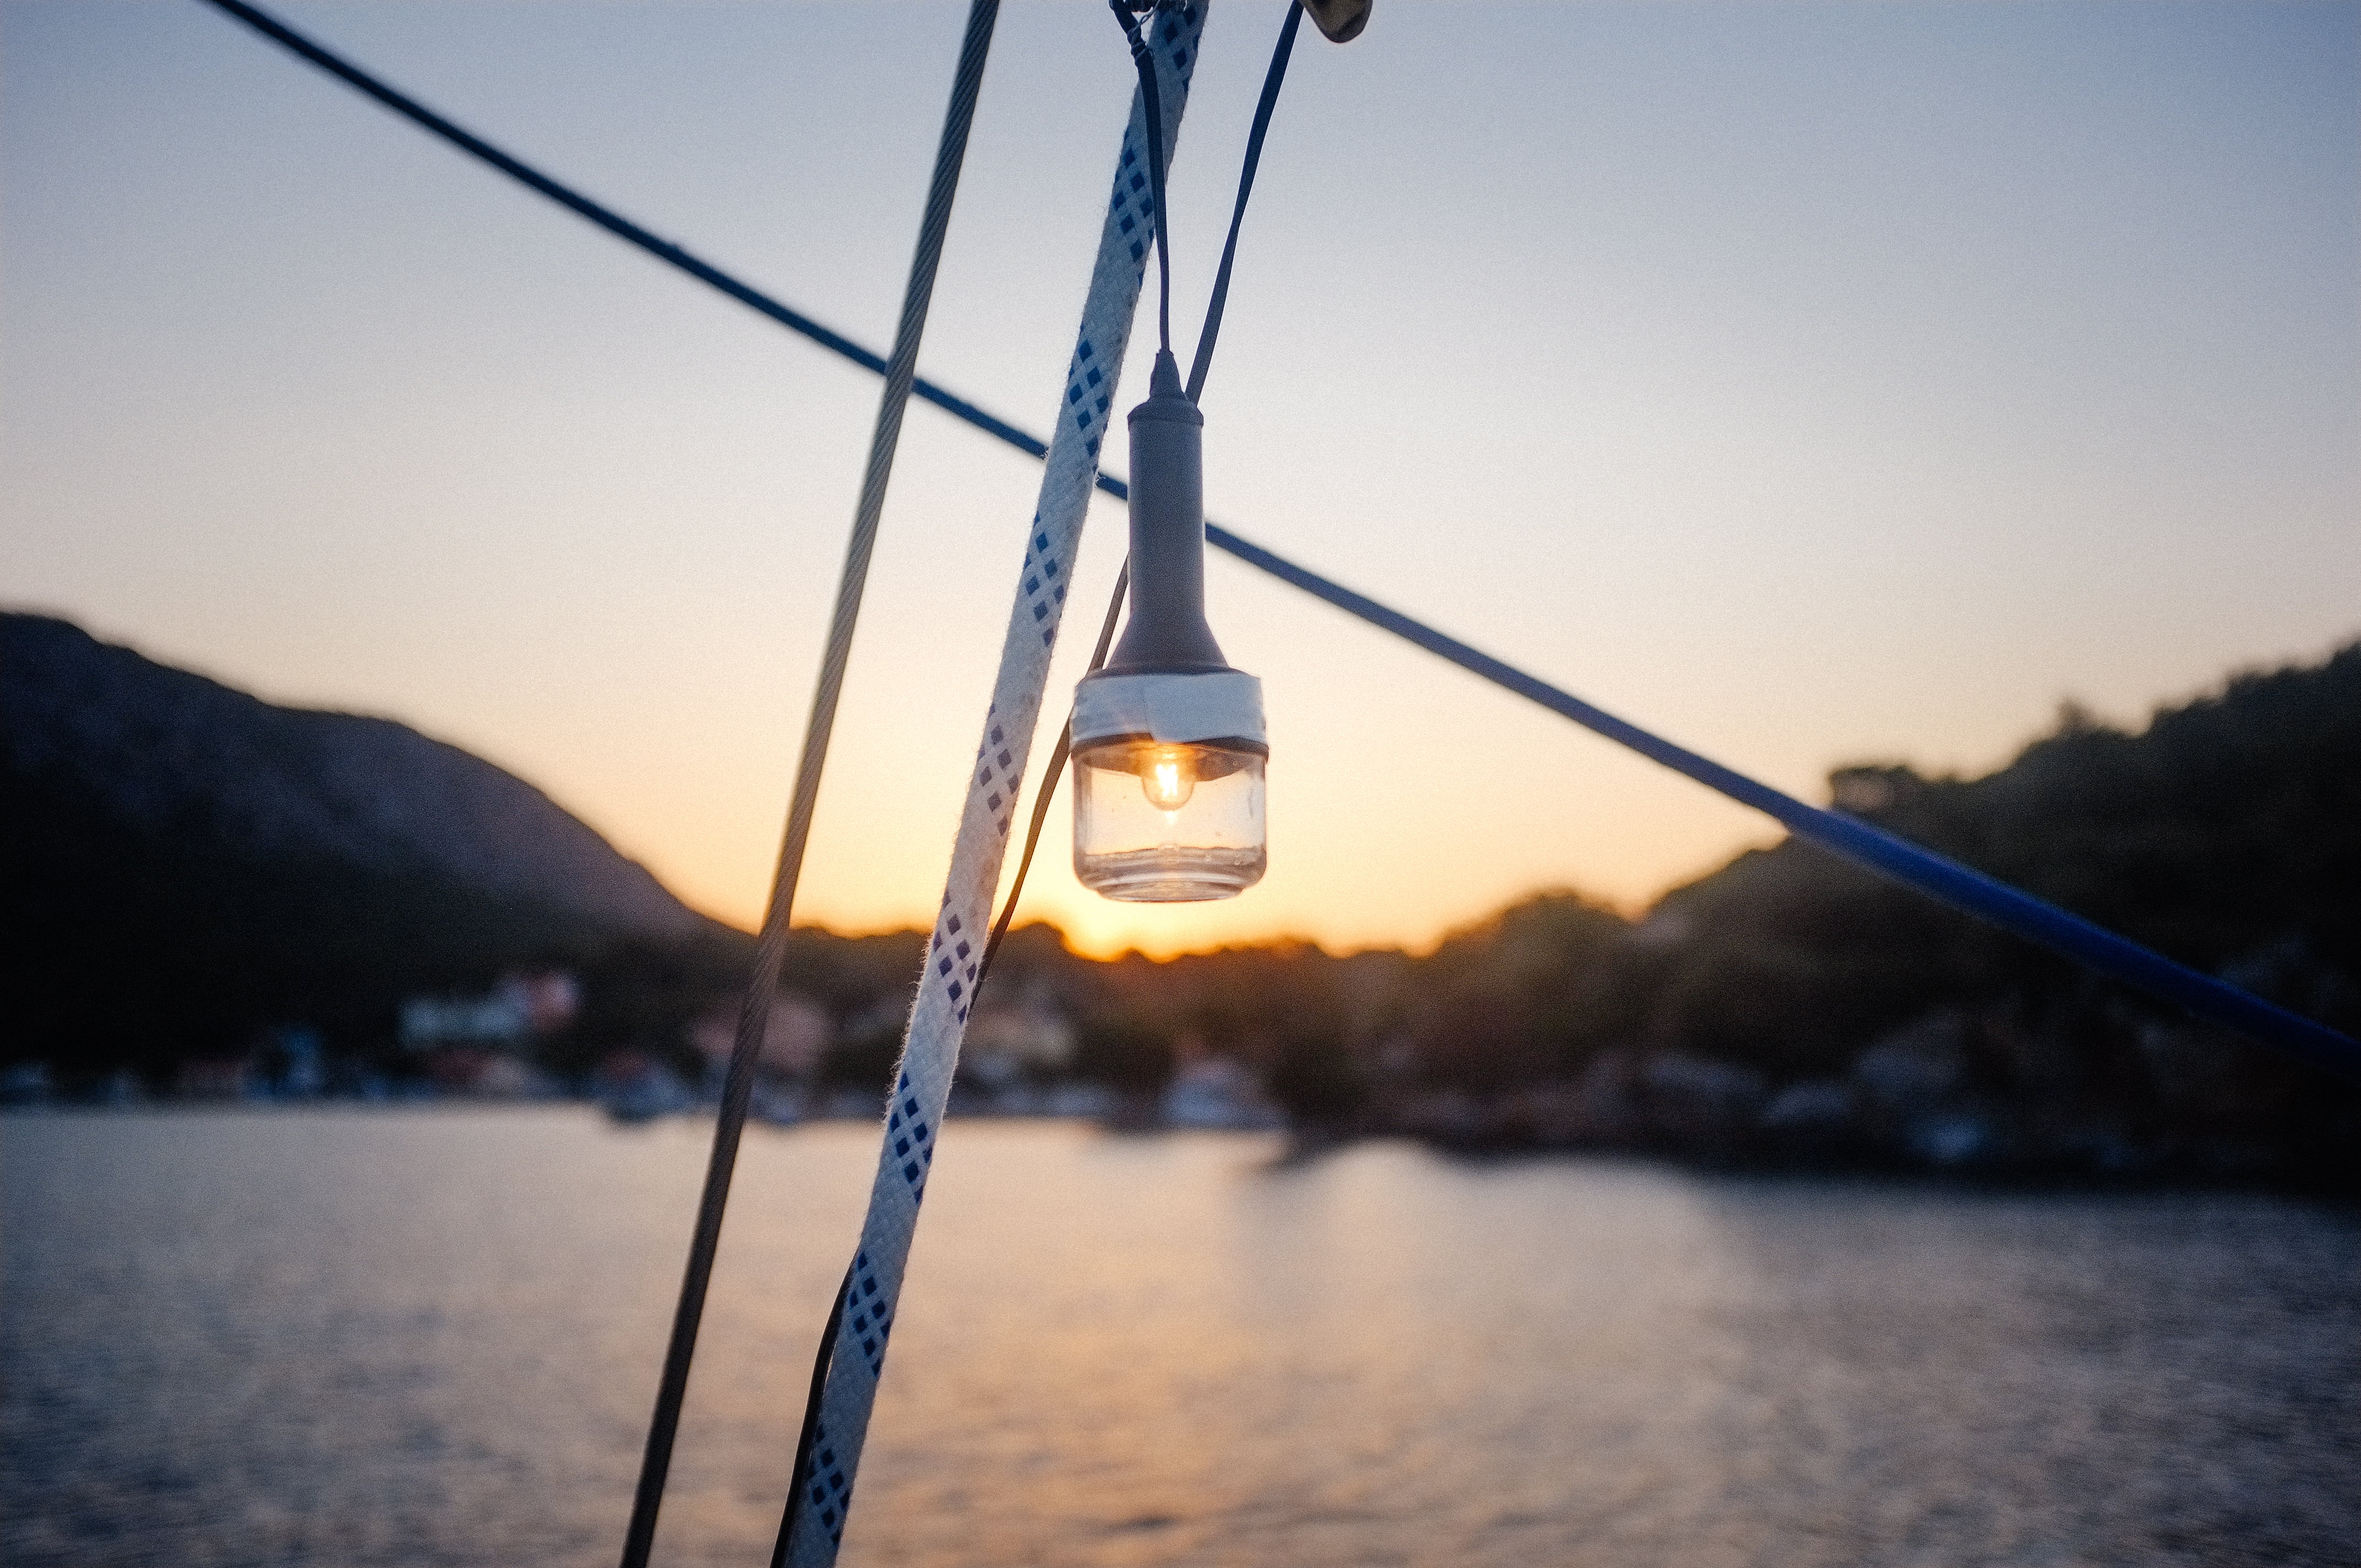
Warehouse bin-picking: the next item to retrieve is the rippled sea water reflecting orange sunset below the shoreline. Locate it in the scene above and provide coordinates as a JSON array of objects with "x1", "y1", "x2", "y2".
[{"x1": 0, "y1": 1108, "x2": 2361, "y2": 1568}]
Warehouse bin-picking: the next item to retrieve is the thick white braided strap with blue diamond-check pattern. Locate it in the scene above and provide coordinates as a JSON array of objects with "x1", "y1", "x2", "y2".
[{"x1": 786, "y1": 0, "x2": 1206, "y2": 1568}]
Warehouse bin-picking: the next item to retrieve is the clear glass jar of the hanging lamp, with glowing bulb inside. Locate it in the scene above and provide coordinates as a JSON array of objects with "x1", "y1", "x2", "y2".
[{"x1": 1074, "y1": 739, "x2": 1268, "y2": 905}]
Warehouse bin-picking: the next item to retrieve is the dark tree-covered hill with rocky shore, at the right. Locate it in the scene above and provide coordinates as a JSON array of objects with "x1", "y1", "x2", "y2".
[{"x1": 1331, "y1": 645, "x2": 2361, "y2": 1183}]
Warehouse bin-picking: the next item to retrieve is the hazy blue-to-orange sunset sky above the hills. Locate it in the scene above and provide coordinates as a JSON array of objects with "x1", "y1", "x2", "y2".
[{"x1": 0, "y1": 0, "x2": 2361, "y2": 952}]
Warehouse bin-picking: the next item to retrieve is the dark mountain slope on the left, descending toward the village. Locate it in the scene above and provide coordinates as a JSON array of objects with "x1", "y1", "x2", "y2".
[{"x1": 0, "y1": 614, "x2": 735, "y2": 1079}]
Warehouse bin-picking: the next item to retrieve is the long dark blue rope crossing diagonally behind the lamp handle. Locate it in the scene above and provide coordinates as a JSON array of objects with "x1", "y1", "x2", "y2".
[{"x1": 210, "y1": 0, "x2": 2361, "y2": 1081}]
